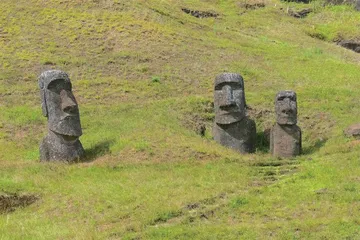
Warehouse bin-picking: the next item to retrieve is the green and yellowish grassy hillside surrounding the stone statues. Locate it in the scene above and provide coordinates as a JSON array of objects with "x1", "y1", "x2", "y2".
[{"x1": 0, "y1": 0, "x2": 360, "y2": 239}]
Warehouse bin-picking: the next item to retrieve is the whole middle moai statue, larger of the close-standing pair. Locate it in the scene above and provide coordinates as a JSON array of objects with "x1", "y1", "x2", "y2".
[{"x1": 213, "y1": 73, "x2": 256, "y2": 153}]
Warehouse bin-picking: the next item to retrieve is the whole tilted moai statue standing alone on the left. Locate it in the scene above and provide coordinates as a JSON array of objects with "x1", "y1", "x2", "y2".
[{"x1": 39, "y1": 70, "x2": 84, "y2": 162}]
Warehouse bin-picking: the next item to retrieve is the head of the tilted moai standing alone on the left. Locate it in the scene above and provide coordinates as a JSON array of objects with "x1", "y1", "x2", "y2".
[{"x1": 39, "y1": 70, "x2": 82, "y2": 138}]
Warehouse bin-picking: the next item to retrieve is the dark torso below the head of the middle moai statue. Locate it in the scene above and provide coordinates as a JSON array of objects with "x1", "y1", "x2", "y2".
[{"x1": 213, "y1": 118, "x2": 256, "y2": 153}]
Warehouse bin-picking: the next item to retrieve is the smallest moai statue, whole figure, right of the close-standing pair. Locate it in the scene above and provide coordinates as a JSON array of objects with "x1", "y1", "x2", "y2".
[{"x1": 270, "y1": 91, "x2": 301, "y2": 158}]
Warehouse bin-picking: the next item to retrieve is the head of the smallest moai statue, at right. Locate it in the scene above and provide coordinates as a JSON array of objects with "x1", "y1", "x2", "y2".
[{"x1": 275, "y1": 91, "x2": 297, "y2": 125}]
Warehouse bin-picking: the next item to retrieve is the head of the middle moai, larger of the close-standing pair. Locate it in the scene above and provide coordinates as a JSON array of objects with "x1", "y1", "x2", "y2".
[{"x1": 214, "y1": 73, "x2": 246, "y2": 124}]
